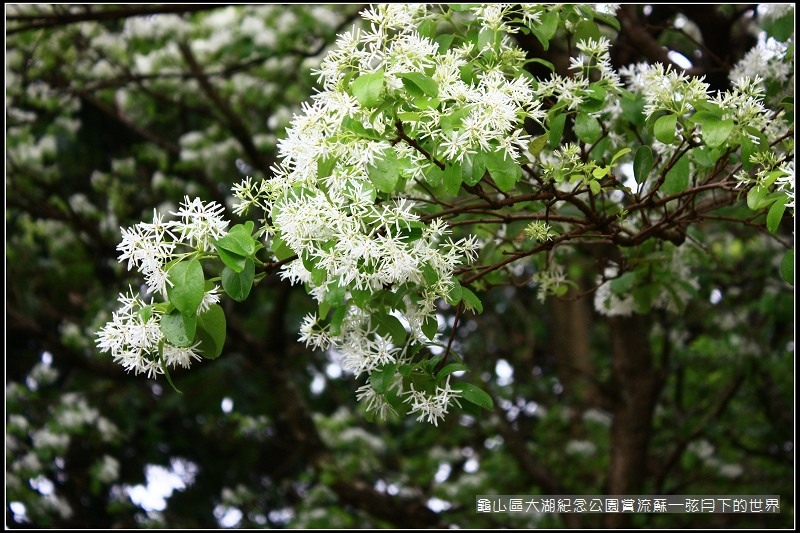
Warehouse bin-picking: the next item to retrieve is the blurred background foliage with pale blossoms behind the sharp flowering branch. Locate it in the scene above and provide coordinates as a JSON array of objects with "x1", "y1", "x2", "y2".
[{"x1": 6, "y1": 4, "x2": 794, "y2": 528}]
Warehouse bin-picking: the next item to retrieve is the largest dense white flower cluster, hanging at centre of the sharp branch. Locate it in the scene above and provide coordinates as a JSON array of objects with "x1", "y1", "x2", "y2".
[{"x1": 233, "y1": 4, "x2": 556, "y2": 422}]
